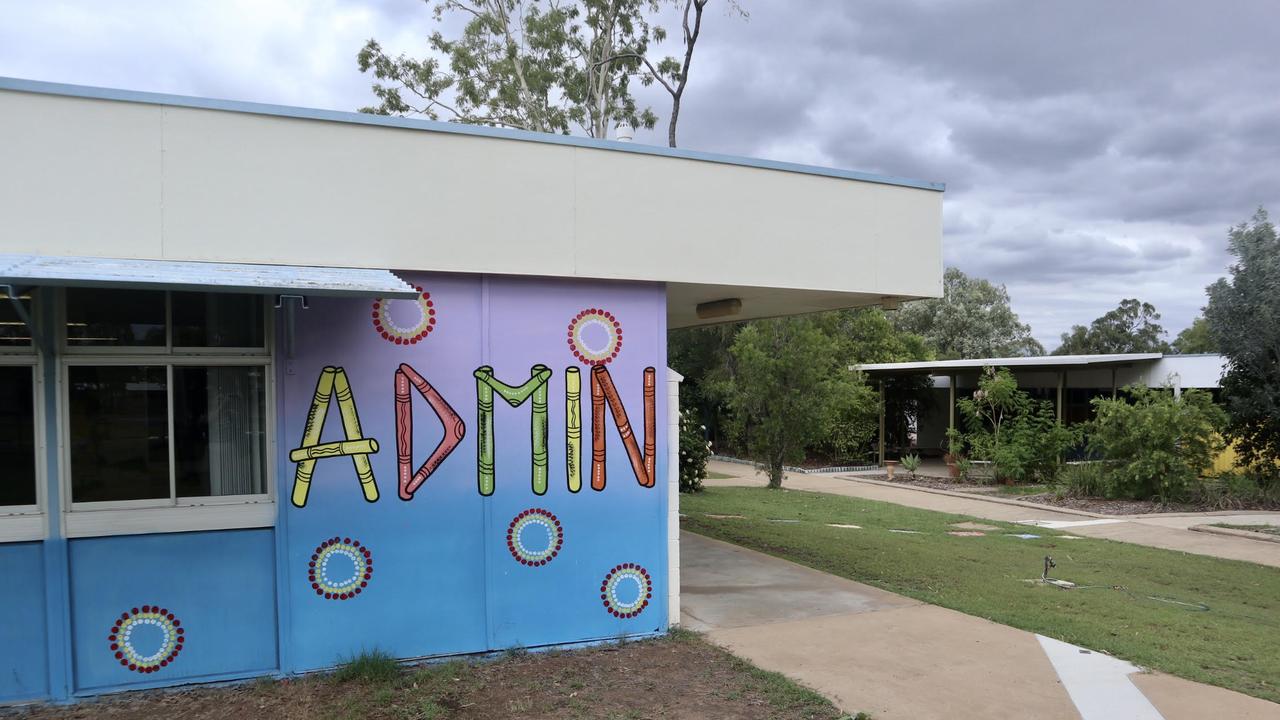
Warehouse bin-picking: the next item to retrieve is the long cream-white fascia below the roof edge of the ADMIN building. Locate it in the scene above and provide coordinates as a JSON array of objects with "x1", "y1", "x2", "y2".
[{"x1": 0, "y1": 90, "x2": 942, "y2": 325}]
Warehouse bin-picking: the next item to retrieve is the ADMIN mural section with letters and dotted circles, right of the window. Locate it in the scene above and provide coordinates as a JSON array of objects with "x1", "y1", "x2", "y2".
[{"x1": 279, "y1": 274, "x2": 667, "y2": 669}]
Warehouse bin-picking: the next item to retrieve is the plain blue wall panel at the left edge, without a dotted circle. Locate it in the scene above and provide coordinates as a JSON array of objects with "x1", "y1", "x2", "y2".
[{"x1": 0, "y1": 542, "x2": 49, "y2": 702}]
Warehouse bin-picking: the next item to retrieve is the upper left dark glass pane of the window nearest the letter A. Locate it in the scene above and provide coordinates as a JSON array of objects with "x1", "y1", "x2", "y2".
[{"x1": 67, "y1": 287, "x2": 165, "y2": 347}]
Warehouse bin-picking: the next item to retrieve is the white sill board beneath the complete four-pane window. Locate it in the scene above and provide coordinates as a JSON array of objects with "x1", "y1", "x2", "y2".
[{"x1": 63, "y1": 501, "x2": 276, "y2": 538}]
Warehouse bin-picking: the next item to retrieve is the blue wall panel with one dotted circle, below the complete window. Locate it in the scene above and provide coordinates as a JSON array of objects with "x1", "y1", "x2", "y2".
[{"x1": 69, "y1": 530, "x2": 278, "y2": 692}]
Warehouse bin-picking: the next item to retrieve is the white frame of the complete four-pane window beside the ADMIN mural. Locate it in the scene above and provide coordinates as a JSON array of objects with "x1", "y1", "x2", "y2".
[{"x1": 56, "y1": 288, "x2": 276, "y2": 537}]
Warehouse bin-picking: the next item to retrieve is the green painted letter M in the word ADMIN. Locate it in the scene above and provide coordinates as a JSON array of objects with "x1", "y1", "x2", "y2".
[{"x1": 475, "y1": 364, "x2": 552, "y2": 495}]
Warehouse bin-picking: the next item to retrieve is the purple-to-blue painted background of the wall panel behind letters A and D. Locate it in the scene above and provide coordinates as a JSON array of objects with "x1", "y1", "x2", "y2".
[{"x1": 278, "y1": 274, "x2": 486, "y2": 670}]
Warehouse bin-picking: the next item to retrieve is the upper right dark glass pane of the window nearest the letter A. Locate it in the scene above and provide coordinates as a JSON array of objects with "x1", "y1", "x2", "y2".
[{"x1": 173, "y1": 292, "x2": 265, "y2": 347}]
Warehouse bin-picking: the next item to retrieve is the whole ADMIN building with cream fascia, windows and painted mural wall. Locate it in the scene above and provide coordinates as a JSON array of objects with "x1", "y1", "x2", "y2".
[{"x1": 0, "y1": 78, "x2": 943, "y2": 703}]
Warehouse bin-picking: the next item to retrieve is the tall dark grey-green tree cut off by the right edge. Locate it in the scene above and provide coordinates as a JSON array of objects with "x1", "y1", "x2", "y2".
[{"x1": 1204, "y1": 208, "x2": 1280, "y2": 464}]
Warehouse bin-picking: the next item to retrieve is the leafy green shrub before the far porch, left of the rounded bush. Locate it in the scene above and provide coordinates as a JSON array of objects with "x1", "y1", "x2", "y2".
[{"x1": 956, "y1": 368, "x2": 1080, "y2": 482}]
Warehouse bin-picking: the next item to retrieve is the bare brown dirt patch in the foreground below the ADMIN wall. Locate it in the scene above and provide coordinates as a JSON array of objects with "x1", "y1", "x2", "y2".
[{"x1": 15, "y1": 633, "x2": 841, "y2": 720}]
